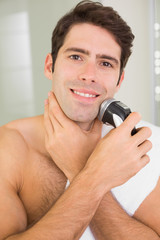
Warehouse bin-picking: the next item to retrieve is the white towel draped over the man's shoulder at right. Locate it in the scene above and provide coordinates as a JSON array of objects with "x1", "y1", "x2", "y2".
[{"x1": 80, "y1": 121, "x2": 160, "y2": 240}]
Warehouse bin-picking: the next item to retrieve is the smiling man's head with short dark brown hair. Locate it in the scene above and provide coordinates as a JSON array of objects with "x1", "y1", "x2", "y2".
[{"x1": 45, "y1": 1, "x2": 134, "y2": 129}]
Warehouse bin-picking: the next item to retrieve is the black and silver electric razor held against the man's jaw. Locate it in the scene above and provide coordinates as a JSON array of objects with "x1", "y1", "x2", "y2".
[{"x1": 98, "y1": 98, "x2": 136, "y2": 135}]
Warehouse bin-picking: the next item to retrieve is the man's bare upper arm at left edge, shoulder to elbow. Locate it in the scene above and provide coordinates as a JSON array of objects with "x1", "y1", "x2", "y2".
[{"x1": 0, "y1": 127, "x2": 27, "y2": 240}]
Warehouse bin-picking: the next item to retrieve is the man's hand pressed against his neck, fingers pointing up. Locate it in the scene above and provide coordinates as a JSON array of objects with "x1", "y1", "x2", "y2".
[{"x1": 44, "y1": 92, "x2": 102, "y2": 181}]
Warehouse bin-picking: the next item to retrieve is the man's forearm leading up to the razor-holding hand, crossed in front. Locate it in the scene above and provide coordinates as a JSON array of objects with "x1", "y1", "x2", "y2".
[{"x1": 6, "y1": 167, "x2": 108, "y2": 240}]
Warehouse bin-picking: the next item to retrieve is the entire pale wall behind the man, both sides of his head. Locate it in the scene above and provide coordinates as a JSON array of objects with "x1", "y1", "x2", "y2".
[{"x1": 0, "y1": 0, "x2": 155, "y2": 125}]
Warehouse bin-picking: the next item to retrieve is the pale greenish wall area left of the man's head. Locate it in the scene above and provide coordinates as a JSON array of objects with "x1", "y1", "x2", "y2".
[{"x1": 0, "y1": 0, "x2": 79, "y2": 125}]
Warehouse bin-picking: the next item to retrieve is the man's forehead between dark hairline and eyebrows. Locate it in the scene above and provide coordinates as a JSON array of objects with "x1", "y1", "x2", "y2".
[{"x1": 62, "y1": 23, "x2": 121, "y2": 62}]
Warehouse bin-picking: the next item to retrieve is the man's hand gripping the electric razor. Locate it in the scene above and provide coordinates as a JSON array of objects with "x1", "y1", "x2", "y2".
[{"x1": 86, "y1": 113, "x2": 152, "y2": 189}]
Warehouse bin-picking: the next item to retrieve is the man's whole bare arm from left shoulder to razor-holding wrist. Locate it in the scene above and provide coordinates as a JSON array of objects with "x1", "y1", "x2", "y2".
[{"x1": 0, "y1": 128, "x2": 134, "y2": 240}]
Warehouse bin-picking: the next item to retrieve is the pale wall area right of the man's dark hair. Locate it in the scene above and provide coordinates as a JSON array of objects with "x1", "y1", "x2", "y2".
[{"x1": 102, "y1": 0, "x2": 154, "y2": 121}]
